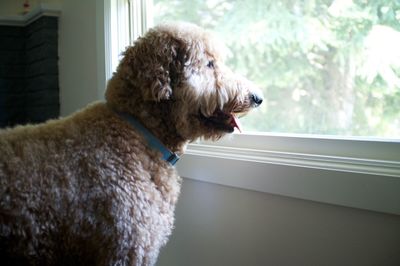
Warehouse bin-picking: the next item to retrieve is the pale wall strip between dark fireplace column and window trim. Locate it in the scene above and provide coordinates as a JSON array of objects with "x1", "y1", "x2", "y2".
[{"x1": 59, "y1": 0, "x2": 105, "y2": 116}]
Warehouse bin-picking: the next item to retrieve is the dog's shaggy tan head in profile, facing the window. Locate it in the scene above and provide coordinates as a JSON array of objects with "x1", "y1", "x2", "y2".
[{"x1": 106, "y1": 23, "x2": 263, "y2": 140}]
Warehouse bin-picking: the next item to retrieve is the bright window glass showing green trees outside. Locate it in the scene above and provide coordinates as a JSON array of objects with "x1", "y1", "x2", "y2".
[{"x1": 154, "y1": 0, "x2": 400, "y2": 139}]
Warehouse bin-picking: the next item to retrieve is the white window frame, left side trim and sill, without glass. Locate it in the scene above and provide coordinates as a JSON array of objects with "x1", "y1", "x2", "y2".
[{"x1": 105, "y1": 0, "x2": 400, "y2": 214}]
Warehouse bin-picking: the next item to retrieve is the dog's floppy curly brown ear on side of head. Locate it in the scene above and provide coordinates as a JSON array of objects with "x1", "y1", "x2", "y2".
[{"x1": 123, "y1": 30, "x2": 185, "y2": 101}]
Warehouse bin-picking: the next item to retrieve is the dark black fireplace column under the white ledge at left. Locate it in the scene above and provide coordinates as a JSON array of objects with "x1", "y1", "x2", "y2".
[{"x1": 0, "y1": 16, "x2": 60, "y2": 127}]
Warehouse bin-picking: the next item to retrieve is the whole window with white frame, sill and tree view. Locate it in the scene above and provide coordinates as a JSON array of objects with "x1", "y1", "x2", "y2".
[{"x1": 106, "y1": 0, "x2": 400, "y2": 214}]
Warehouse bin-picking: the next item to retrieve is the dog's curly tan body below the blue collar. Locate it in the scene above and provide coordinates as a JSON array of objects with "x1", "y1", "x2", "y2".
[{"x1": 0, "y1": 103, "x2": 180, "y2": 265}]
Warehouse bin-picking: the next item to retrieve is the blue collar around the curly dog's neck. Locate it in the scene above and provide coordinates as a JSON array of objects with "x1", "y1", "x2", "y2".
[{"x1": 118, "y1": 112, "x2": 179, "y2": 165}]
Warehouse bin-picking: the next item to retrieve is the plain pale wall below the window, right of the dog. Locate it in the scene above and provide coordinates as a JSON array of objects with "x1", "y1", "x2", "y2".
[{"x1": 157, "y1": 179, "x2": 400, "y2": 266}]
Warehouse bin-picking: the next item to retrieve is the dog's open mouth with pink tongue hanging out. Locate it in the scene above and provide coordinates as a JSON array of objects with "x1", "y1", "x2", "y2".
[{"x1": 200, "y1": 110, "x2": 242, "y2": 133}]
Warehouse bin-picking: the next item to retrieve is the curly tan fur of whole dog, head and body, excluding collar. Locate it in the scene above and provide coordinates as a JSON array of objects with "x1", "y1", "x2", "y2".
[{"x1": 0, "y1": 21, "x2": 262, "y2": 265}]
